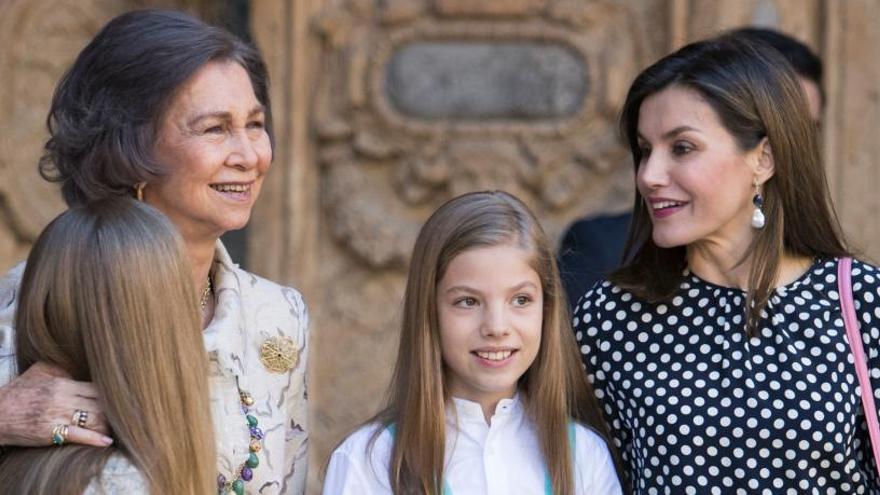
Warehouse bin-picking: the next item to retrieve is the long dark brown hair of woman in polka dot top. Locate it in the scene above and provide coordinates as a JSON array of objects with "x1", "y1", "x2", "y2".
[{"x1": 610, "y1": 34, "x2": 848, "y2": 335}]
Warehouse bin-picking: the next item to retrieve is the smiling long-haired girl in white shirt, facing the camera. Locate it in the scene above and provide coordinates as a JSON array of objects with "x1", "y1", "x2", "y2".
[{"x1": 324, "y1": 192, "x2": 621, "y2": 495}]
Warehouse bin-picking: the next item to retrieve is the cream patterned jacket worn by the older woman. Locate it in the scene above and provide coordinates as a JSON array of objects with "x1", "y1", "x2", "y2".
[{"x1": 0, "y1": 241, "x2": 308, "y2": 495}]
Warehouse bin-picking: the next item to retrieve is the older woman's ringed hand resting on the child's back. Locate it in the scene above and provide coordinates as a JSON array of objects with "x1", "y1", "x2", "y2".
[{"x1": 0, "y1": 363, "x2": 113, "y2": 447}]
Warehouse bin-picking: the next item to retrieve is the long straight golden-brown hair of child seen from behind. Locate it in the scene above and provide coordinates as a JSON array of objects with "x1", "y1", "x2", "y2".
[{"x1": 0, "y1": 198, "x2": 216, "y2": 495}]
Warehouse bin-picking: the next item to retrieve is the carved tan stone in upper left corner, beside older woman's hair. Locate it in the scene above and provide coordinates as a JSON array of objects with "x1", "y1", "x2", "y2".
[{"x1": 0, "y1": 0, "x2": 130, "y2": 267}]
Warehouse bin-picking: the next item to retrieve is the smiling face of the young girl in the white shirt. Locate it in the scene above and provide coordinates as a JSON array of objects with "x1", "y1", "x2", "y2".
[{"x1": 437, "y1": 243, "x2": 544, "y2": 411}]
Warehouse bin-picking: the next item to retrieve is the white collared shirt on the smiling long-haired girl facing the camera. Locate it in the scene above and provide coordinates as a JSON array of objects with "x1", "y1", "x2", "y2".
[{"x1": 324, "y1": 396, "x2": 621, "y2": 495}]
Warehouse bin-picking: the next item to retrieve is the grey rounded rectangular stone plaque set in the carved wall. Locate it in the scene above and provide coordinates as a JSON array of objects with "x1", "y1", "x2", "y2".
[{"x1": 385, "y1": 41, "x2": 589, "y2": 121}]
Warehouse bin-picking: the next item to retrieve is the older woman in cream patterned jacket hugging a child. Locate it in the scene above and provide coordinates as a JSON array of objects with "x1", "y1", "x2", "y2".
[{"x1": 0, "y1": 10, "x2": 307, "y2": 493}]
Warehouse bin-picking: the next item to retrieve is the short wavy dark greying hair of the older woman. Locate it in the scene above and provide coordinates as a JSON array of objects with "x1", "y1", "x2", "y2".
[{"x1": 40, "y1": 10, "x2": 273, "y2": 206}]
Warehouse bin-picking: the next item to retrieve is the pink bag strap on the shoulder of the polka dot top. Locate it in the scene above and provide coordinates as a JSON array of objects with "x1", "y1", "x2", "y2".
[{"x1": 837, "y1": 257, "x2": 880, "y2": 473}]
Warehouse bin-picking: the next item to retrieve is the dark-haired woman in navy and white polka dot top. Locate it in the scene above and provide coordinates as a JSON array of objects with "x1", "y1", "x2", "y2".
[{"x1": 574, "y1": 33, "x2": 880, "y2": 494}]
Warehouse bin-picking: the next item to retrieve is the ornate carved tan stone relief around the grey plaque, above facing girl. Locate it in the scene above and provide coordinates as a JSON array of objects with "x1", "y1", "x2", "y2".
[{"x1": 313, "y1": 0, "x2": 642, "y2": 270}]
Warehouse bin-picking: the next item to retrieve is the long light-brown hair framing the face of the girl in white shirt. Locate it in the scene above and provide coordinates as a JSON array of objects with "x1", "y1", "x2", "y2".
[{"x1": 370, "y1": 191, "x2": 608, "y2": 494}]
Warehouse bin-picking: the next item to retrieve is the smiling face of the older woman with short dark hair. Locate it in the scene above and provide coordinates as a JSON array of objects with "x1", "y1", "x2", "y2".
[{"x1": 144, "y1": 61, "x2": 272, "y2": 241}]
